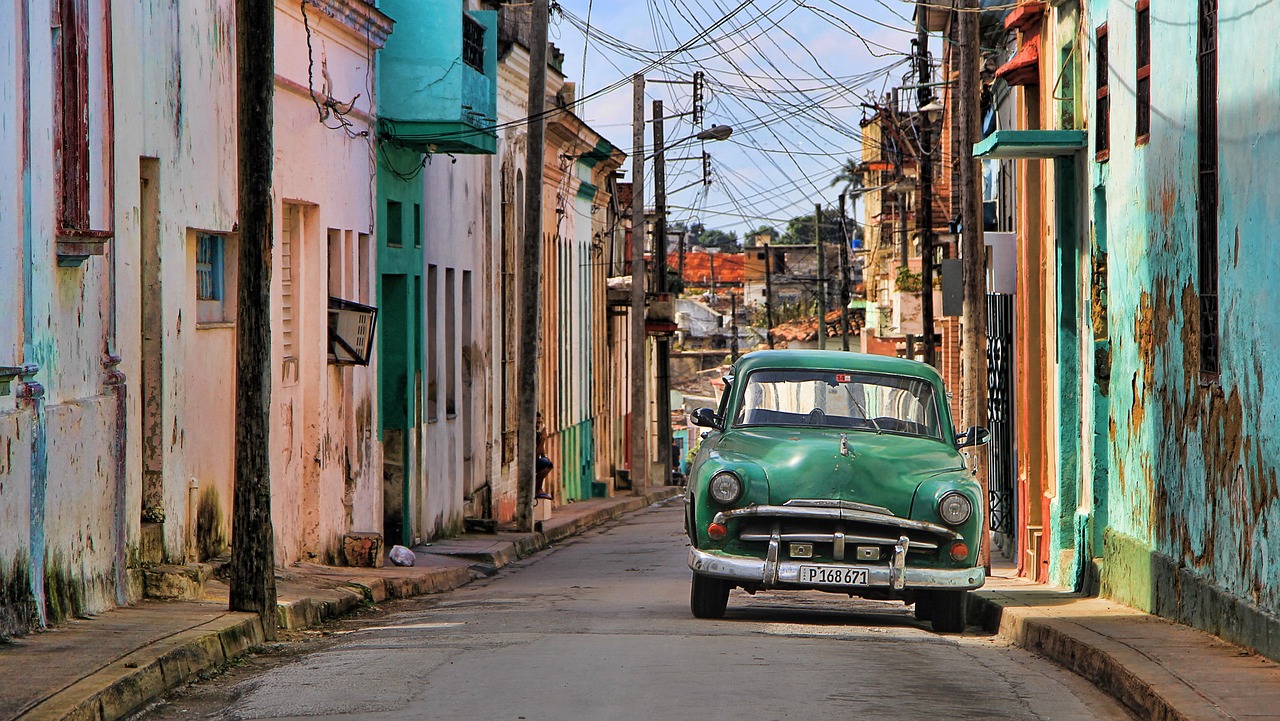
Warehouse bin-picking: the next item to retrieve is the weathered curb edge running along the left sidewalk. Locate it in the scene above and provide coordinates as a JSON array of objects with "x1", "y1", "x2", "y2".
[{"x1": 17, "y1": 488, "x2": 680, "y2": 721}]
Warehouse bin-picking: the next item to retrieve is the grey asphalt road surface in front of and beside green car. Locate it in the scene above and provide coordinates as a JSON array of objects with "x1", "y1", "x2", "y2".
[{"x1": 145, "y1": 498, "x2": 1130, "y2": 721}]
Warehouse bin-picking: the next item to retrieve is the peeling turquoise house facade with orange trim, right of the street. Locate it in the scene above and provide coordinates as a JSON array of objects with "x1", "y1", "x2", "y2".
[{"x1": 974, "y1": 0, "x2": 1280, "y2": 657}]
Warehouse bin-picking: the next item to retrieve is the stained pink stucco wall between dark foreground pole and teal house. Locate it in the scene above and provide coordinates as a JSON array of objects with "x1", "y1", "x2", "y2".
[{"x1": 272, "y1": 3, "x2": 381, "y2": 563}]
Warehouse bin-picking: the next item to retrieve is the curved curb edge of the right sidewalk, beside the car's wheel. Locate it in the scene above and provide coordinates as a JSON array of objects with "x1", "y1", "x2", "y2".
[{"x1": 968, "y1": 592, "x2": 1198, "y2": 721}]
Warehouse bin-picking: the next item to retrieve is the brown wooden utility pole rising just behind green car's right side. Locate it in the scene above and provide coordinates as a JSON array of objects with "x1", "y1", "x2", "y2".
[{"x1": 956, "y1": 0, "x2": 991, "y2": 567}]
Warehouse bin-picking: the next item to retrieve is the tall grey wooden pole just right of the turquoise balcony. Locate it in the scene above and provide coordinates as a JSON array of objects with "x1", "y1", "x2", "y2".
[{"x1": 516, "y1": 0, "x2": 548, "y2": 533}]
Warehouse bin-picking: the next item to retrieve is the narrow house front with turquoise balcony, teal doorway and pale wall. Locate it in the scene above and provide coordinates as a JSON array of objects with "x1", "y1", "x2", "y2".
[{"x1": 376, "y1": 0, "x2": 498, "y2": 544}]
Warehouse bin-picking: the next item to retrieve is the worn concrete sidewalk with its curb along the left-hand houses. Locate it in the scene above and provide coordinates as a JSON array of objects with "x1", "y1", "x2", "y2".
[{"x1": 0, "y1": 487, "x2": 682, "y2": 721}]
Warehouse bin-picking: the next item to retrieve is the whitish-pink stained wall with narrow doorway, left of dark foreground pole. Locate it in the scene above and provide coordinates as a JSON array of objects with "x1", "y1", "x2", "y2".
[{"x1": 113, "y1": 0, "x2": 237, "y2": 571}]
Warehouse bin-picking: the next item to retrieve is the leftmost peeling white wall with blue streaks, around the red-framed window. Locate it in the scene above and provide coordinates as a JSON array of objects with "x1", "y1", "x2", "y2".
[{"x1": 0, "y1": 1, "x2": 123, "y2": 635}]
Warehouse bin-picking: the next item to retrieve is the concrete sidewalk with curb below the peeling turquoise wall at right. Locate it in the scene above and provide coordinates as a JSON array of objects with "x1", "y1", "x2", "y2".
[{"x1": 969, "y1": 569, "x2": 1280, "y2": 721}]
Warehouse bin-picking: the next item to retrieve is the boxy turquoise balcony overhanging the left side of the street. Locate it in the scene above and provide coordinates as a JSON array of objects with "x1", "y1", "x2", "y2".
[{"x1": 378, "y1": 0, "x2": 498, "y2": 155}]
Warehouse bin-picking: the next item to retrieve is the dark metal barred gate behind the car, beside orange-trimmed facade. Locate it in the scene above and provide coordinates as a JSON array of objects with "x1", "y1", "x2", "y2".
[{"x1": 987, "y1": 293, "x2": 1018, "y2": 535}]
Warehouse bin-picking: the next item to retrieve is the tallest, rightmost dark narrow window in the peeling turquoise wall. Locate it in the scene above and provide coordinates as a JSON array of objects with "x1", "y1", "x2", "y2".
[{"x1": 1196, "y1": 0, "x2": 1220, "y2": 377}]
